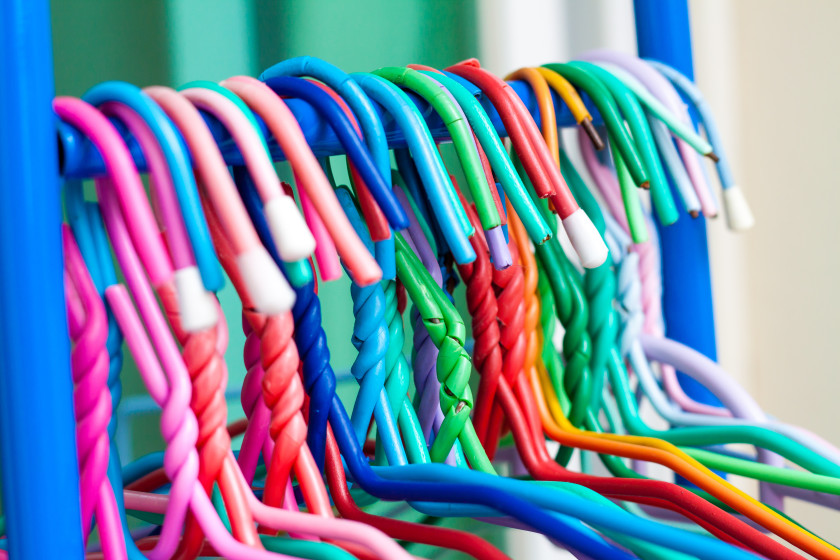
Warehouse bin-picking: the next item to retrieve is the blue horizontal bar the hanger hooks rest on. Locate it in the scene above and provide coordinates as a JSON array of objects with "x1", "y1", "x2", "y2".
[{"x1": 58, "y1": 81, "x2": 599, "y2": 179}]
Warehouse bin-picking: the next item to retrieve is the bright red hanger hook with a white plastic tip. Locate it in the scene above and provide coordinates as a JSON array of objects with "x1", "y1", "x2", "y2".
[{"x1": 447, "y1": 60, "x2": 607, "y2": 266}]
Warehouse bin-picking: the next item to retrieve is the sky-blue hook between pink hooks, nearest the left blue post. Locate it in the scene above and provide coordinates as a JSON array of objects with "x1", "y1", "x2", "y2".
[{"x1": 83, "y1": 82, "x2": 224, "y2": 291}]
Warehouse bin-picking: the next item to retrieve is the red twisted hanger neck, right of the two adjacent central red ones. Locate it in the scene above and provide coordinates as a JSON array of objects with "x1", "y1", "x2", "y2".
[{"x1": 487, "y1": 238, "x2": 526, "y2": 457}]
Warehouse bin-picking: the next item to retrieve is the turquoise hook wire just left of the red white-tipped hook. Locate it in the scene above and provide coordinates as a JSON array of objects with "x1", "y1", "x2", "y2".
[{"x1": 410, "y1": 68, "x2": 551, "y2": 243}]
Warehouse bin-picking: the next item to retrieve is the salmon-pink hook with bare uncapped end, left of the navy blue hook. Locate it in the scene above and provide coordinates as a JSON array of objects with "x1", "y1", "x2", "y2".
[{"x1": 222, "y1": 76, "x2": 382, "y2": 285}]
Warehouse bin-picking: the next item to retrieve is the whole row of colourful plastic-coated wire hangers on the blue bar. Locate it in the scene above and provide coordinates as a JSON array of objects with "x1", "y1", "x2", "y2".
[{"x1": 18, "y1": 51, "x2": 840, "y2": 560}]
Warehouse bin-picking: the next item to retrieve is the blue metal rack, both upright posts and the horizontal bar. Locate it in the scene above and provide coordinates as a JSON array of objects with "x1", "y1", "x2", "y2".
[{"x1": 0, "y1": 0, "x2": 715, "y2": 560}]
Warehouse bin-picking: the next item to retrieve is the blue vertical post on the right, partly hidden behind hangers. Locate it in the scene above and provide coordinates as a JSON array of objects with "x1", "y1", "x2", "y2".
[{"x1": 634, "y1": 0, "x2": 719, "y2": 404}]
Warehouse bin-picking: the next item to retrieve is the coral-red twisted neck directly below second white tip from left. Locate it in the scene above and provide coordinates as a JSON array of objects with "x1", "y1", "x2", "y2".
[{"x1": 244, "y1": 309, "x2": 306, "y2": 506}]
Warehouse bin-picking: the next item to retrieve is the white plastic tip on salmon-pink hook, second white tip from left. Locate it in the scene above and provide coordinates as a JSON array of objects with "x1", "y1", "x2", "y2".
[{"x1": 236, "y1": 247, "x2": 295, "y2": 315}]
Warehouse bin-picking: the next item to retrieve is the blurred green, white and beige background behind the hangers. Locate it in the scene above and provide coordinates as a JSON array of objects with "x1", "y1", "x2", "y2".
[{"x1": 52, "y1": 0, "x2": 840, "y2": 558}]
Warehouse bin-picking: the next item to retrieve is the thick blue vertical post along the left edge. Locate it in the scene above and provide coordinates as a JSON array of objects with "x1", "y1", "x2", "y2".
[{"x1": 0, "y1": 0, "x2": 84, "y2": 560}]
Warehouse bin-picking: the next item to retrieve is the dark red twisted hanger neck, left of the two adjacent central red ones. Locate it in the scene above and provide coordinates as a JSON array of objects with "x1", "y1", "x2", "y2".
[{"x1": 458, "y1": 229, "x2": 503, "y2": 448}]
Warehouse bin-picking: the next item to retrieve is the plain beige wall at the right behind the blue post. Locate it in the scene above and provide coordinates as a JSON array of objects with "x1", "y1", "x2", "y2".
[{"x1": 692, "y1": 0, "x2": 840, "y2": 541}]
